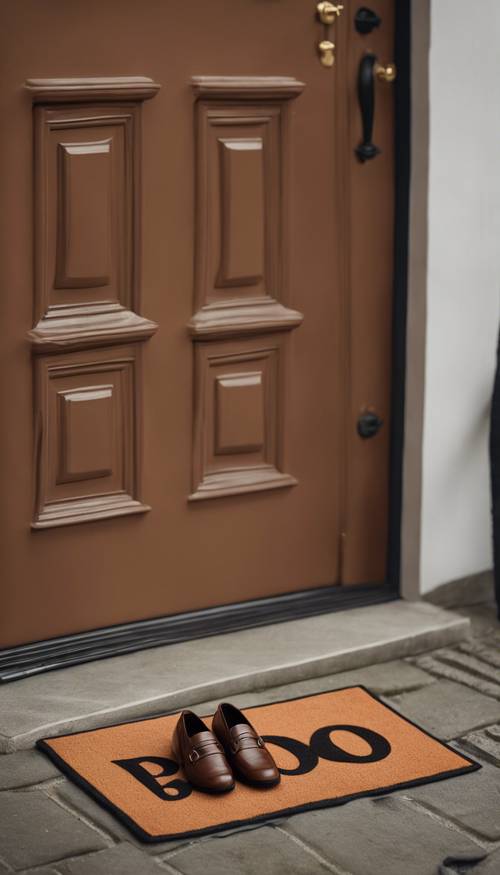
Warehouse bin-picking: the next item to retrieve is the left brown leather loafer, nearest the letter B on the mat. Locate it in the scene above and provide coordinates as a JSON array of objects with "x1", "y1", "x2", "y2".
[{"x1": 172, "y1": 711, "x2": 234, "y2": 793}]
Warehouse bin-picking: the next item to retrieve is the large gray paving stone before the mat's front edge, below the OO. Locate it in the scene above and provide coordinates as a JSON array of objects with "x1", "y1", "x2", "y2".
[{"x1": 286, "y1": 796, "x2": 477, "y2": 875}]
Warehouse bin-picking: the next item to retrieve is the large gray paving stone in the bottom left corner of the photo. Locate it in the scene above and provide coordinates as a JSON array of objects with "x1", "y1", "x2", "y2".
[{"x1": 0, "y1": 790, "x2": 107, "y2": 869}]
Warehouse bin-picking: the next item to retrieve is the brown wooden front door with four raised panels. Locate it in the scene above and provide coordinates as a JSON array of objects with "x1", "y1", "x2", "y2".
[{"x1": 0, "y1": 0, "x2": 393, "y2": 647}]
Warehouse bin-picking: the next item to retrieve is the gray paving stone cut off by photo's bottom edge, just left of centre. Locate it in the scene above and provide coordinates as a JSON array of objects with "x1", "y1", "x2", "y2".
[{"x1": 166, "y1": 826, "x2": 331, "y2": 875}]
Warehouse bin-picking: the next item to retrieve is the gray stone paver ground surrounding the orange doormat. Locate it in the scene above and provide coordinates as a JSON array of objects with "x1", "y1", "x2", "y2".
[{"x1": 0, "y1": 606, "x2": 500, "y2": 875}]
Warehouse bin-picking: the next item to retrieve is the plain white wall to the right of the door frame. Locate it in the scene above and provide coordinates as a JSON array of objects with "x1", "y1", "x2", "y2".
[{"x1": 415, "y1": 0, "x2": 500, "y2": 592}]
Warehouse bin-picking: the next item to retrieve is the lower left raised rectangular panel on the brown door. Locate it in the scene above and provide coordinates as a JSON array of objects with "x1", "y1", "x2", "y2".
[{"x1": 32, "y1": 344, "x2": 146, "y2": 529}]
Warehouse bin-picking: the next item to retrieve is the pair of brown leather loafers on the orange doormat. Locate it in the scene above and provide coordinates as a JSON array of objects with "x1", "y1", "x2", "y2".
[{"x1": 172, "y1": 702, "x2": 280, "y2": 793}]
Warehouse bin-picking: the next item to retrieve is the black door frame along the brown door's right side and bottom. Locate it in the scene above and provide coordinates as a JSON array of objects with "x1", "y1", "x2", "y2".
[{"x1": 0, "y1": 0, "x2": 411, "y2": 683}]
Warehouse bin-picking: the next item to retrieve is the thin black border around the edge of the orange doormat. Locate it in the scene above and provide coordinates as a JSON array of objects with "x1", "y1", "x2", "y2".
[{"x1": 36, "y1": 684, "x2": 482, "y2": 844}]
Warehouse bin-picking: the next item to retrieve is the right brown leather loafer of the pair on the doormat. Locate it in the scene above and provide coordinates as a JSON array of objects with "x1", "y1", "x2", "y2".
[{"x1": 212, "y1": 702, "x2": 281, "y2": 787}]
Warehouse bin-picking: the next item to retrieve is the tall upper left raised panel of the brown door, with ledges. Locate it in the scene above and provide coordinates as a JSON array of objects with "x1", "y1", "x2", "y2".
[{"x1": 26, "y1": 77, "x2": 160, "y2": 353}]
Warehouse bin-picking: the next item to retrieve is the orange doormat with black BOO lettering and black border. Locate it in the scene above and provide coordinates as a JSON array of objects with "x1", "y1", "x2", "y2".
[{"x1": 37, "y1": 686, "x2": 480, "y2": 842}]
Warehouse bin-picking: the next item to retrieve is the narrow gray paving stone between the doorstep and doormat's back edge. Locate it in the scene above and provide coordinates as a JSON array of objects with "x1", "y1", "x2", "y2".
[{"x1": 196, "y1": 659, "x2": 436, "y2": 714}]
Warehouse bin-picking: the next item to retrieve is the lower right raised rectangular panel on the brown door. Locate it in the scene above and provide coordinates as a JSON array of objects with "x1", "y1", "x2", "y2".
[{"x1": 189, "y1": 335, "x2": 297, "y2": 501}]
